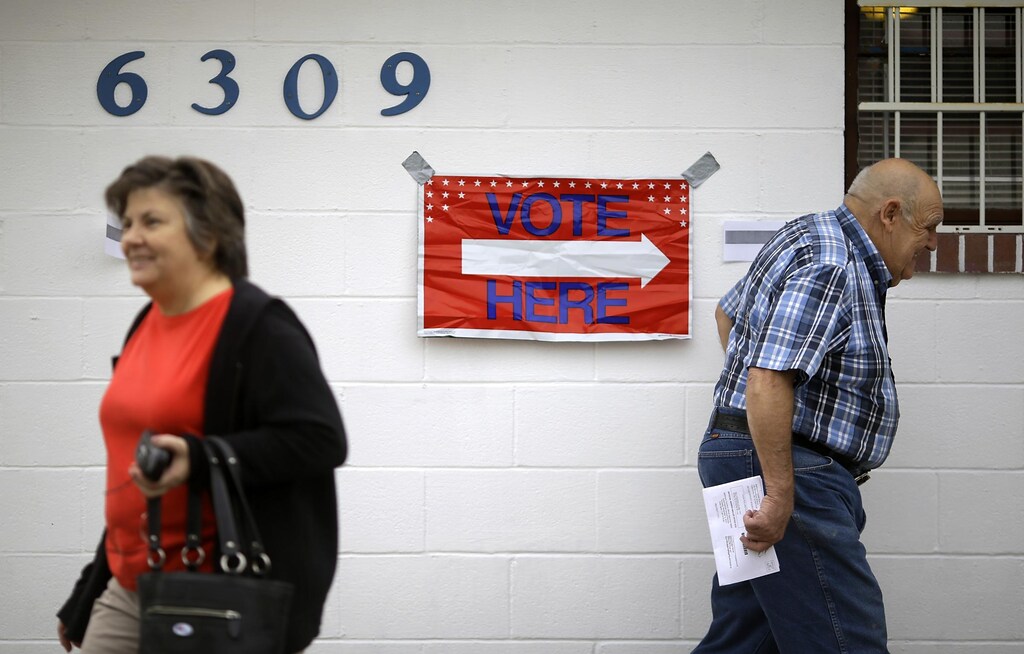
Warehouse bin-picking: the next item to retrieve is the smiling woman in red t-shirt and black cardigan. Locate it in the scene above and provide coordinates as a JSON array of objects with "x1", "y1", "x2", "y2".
[{"x1": 57, "y1": 157, "x2": 346, "y2": 654}]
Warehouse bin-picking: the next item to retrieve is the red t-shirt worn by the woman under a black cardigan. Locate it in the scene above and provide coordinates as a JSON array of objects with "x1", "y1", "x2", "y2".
[{"x1": 99, "y1": 289, "x2": 233, "y2": 591}]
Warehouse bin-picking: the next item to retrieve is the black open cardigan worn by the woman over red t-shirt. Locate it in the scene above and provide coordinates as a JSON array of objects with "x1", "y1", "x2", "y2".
[{"x1": 57, "y1": 279, "x2": 347, "y2": 652}]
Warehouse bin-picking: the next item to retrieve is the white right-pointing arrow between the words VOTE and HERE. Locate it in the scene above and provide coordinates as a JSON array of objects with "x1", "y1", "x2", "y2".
[{"x1": 462, "y1": 234, "x2": 669, "y2": 288}]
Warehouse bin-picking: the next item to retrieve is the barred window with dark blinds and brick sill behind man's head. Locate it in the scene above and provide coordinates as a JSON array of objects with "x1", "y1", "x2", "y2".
[{"x1": 846, "y1": 0, "x2": 1024, "y2": 272}]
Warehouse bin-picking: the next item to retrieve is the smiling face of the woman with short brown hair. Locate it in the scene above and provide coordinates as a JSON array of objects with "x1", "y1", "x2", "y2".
[{"x1": 121, "y1": 187, "x2": 212, "y2": 299}]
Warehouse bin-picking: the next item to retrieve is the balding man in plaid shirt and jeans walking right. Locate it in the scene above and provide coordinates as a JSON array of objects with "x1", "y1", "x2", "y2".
[{"x1": 694, "y1": 159, "x2": 942, "y2": 654}]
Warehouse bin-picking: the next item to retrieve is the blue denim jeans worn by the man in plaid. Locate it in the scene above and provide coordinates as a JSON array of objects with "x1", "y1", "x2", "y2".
[{"x1": 693, "y1": 413, "x2": 889, "y2": 654}]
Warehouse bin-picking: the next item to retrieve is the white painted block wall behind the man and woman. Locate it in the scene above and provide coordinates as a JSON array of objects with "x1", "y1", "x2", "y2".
[{"x1": 0, "y1": 0, "x2": 1024, "y2": 654}]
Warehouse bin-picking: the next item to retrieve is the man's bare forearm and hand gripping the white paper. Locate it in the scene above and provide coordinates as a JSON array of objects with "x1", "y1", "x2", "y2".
[{"x1": 740, "y1": 367, "x2": 796, "y2": 552}]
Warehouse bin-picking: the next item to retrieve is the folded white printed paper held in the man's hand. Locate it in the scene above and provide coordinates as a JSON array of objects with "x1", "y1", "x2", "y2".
[{"x1": 703, "y1": 477, "x2": 778, "y2": 585}]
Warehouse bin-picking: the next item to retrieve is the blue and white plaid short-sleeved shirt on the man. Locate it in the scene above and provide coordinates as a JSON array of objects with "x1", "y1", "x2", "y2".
[{"x1": 715, "y1": 205, "x2": 899, "y2": 468}]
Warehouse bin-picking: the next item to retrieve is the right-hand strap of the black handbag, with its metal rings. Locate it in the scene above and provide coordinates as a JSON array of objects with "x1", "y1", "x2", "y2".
[{"x1": 205, "y1": 436, "x2": 270, "y2": 576}]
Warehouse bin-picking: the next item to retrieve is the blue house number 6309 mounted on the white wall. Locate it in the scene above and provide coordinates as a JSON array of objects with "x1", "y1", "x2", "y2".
[{"x1": 96, "y1": 50, "x2": 430, "y2": 121}]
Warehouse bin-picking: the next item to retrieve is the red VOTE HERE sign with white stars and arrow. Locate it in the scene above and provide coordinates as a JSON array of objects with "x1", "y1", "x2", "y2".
[{"x1": 419, "y1": 174, "x2": 691, "y2": 341}]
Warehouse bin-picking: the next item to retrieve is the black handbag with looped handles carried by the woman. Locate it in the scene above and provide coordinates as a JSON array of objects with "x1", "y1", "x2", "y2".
[{"x1": 138, "y1": 436, "x2": 294, "y2": 654}]
